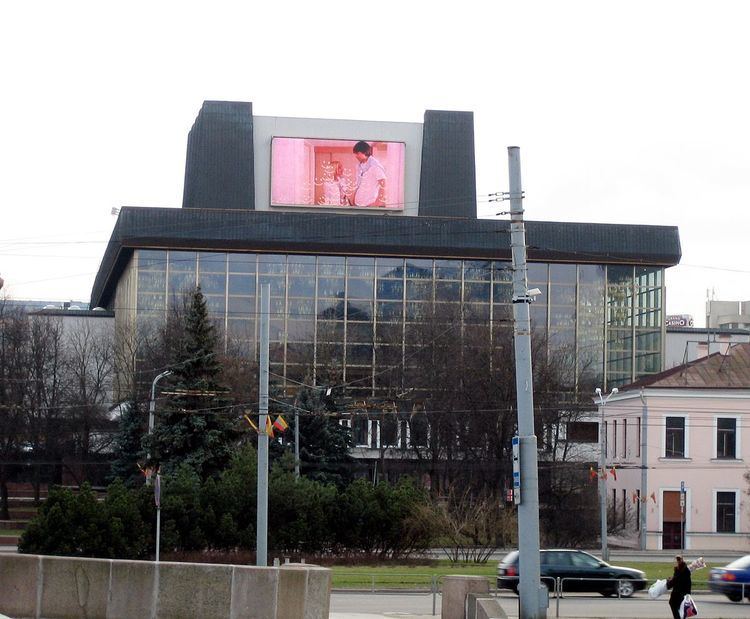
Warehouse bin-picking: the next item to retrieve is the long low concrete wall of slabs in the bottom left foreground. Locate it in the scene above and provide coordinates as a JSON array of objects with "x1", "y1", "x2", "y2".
[{"x1": 0, "y1": 554, "x2": 331, "y2": 619}]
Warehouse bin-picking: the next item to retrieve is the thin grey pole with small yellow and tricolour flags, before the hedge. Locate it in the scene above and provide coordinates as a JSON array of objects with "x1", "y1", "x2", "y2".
[{"x1": 255, "y1": 284, "x2": 271, "y2": 567}]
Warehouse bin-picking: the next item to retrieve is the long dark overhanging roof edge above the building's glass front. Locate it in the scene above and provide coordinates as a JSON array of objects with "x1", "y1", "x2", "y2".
[{"x1": 91, "y1": 207, "x2": 681, "y2": 307}]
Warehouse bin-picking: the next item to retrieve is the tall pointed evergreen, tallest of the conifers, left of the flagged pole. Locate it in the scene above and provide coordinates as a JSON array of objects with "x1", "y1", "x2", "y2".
[{"x1": 147, "y1": 287, "x2": 239, "y2": 479}]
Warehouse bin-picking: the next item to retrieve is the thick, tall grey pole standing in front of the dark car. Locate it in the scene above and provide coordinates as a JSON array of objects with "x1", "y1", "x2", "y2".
[{"x1": 508, "y1": 146, "x2": 547, "y2": 619}]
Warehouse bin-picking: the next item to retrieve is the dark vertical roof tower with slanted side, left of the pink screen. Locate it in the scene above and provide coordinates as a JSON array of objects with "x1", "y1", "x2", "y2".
[{"x1": 182, "y1": 101, "x2": 255, "y2": 210}]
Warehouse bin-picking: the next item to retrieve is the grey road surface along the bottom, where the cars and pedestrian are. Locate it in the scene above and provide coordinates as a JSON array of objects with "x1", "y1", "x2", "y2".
[{"x1": 330, "y1": 593, "x2": 750, "y2": 619}]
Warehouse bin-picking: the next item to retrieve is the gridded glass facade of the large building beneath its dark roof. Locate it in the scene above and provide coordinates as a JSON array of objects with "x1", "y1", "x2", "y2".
[{"x1": 114, "y1": 249, "x2": 664, "y2": 394}]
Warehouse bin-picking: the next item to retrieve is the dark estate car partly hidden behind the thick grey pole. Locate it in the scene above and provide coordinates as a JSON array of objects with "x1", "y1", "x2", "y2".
[{"x1": 497, "y1": 550, "x2": 646, "y2": 598}]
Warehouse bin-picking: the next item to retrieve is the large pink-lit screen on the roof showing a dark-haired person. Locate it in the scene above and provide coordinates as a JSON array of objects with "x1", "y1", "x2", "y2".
[{"x1": 271, "y1": 137, "x2": 406, "y2": 210}]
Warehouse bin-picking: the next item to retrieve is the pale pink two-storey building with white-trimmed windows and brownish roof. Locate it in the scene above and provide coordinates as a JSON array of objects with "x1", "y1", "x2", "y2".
[{"x1": 600, "y1": 344, "x2": 750, "y2": 552}]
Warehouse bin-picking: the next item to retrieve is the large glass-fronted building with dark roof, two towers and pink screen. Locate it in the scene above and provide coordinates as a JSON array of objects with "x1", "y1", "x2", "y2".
[{"x1": 91, "y1": 102, "x2": 680, "y2": 464}]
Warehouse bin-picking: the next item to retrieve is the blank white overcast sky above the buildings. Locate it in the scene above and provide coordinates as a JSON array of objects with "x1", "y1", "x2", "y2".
[{"x1": 0, "y1": 0, "x2": 750, "y2": 326}]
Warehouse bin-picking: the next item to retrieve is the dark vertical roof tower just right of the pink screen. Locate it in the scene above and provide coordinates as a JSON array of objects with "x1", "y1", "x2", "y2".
[{"x1": 419, "y1": 110, "x2": 477, "y2": 219}]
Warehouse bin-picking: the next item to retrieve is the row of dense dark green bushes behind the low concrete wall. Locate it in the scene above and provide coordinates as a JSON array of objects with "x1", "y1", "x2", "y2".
[{"x1": 19, "y1": 448, "x2": 433, "y2": 558}]
